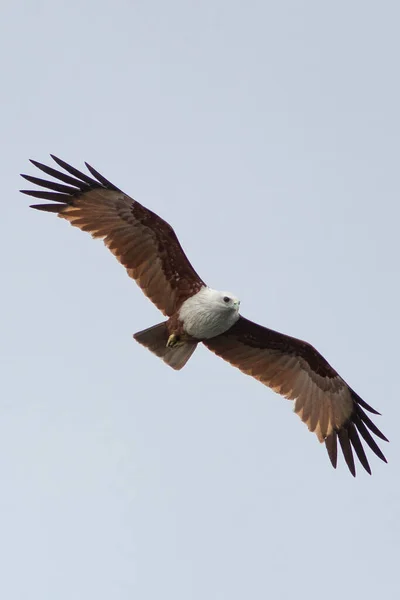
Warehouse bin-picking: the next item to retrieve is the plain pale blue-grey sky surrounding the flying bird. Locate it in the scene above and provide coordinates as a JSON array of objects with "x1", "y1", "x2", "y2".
[{"x1": 0, "y1": 0, "x2": 400, "y2": 600}]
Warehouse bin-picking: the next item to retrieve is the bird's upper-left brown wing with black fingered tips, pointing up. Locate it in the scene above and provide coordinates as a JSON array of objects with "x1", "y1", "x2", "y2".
[{"x1": 21, "y1": 155, "x2": 205, "y2": 316}]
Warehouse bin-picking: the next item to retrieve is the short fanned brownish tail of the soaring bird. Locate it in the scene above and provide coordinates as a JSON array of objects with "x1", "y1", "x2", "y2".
[{"x1": 133, "y1": 321, "x2": 197, "y2": 371}]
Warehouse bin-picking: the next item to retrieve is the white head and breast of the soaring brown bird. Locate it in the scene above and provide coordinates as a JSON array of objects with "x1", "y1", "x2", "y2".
[{"x1": 179, "y1": 287, "x2": 239, "y2": 339}]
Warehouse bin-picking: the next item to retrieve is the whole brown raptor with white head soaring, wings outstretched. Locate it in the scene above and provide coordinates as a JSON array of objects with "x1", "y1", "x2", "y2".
[{"x1": 21, "y1": 156, "x2": 387, "y2": 476}]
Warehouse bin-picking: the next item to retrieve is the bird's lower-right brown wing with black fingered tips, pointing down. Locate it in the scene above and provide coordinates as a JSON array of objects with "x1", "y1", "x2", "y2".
[{"x1": 203, "y1": 317, "x2": 387, "y2": 476}]
